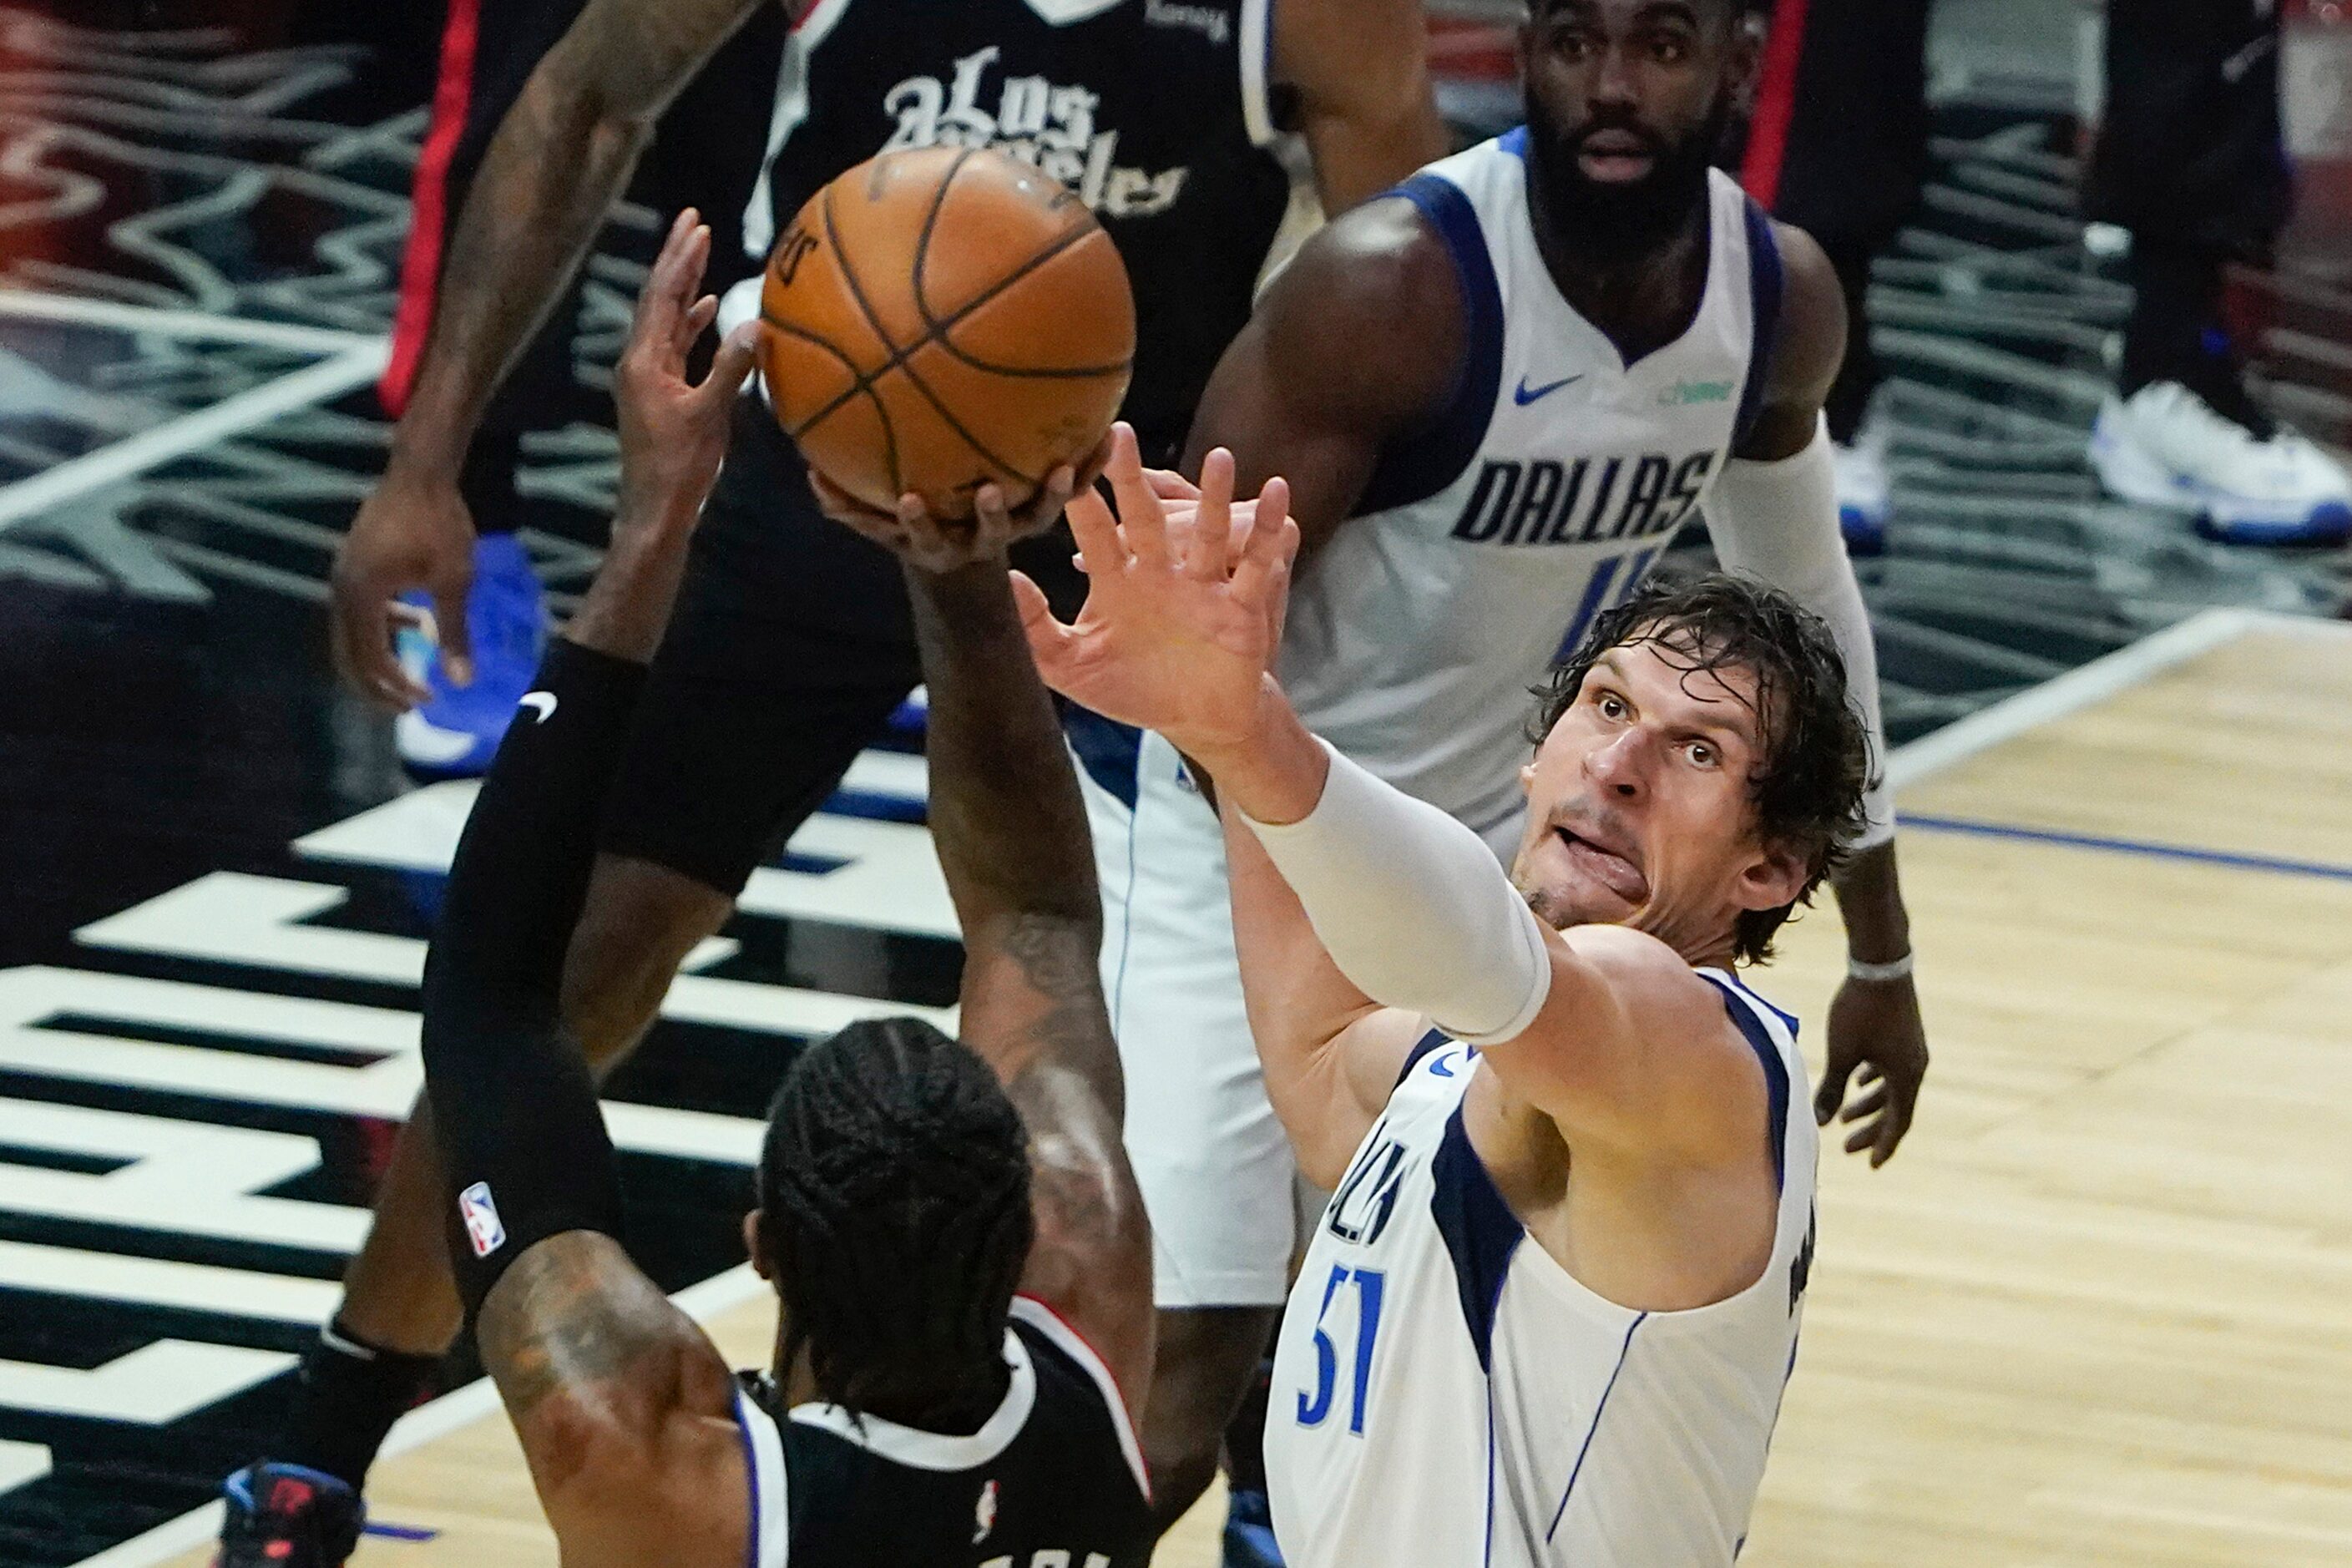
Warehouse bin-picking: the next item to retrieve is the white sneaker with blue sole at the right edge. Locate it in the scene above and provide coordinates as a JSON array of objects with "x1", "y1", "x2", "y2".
[{"x1": 2091, "y1": 381, "x2": 2352, "y2": 545}]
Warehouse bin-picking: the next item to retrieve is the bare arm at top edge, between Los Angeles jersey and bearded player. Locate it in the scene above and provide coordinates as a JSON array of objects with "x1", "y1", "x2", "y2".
[{"x1": 1275, "y1": 0, "x2": 1446, "y2": 216}]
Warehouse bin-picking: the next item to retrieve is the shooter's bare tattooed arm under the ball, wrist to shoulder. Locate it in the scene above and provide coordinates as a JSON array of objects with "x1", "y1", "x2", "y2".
[{"x1": 906, "y1": 554, "x2": 1152, "y2": 1422}]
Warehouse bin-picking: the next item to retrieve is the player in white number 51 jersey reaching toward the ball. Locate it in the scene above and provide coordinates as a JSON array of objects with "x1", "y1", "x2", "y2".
[{"x1": 1019, "y1": 446, "x2": 1868, "y2": 1568}]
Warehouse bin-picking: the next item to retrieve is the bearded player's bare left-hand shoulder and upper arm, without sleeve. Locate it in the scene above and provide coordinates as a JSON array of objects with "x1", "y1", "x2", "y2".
[{"x1": 1183, "y1": 200, "x2": 1465, "y2": 567}]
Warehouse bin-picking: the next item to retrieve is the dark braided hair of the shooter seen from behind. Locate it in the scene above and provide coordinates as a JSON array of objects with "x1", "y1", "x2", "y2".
[{"x1": 760, "y1": 1018, "x2": 1033, "y2": 1424}]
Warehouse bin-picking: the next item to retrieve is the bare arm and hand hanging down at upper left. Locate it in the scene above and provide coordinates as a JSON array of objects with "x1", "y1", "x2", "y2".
[{"x1": 331, "y1": 0, "x2": 766, "y2": 707}]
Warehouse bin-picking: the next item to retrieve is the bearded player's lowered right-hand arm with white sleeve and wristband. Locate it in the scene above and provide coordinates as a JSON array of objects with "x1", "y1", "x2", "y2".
[{"x1": 1707, "y1": 223, "x2": 1929, "y2": 1166}]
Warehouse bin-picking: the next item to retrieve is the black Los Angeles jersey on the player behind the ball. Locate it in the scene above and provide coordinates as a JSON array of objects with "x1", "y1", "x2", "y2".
[{"x1": 743, "y1": 0, "x2": 1289, "y2": 465}]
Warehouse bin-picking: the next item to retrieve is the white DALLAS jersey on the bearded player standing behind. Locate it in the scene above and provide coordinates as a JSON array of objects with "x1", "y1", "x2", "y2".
[{"x1": 1279, "y1": 129, "x2": 1780, "y2": 832}]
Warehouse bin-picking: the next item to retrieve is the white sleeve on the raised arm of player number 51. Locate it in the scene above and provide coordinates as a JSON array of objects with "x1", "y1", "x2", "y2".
[{"x1": 1242, "y1": 746, "x2": 1552, "y2": 1046}]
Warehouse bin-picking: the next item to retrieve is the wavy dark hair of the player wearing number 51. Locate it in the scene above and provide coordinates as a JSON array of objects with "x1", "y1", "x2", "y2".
[{"x1": 1526, "y1": 571, "x2": 1870, "y2": 964}]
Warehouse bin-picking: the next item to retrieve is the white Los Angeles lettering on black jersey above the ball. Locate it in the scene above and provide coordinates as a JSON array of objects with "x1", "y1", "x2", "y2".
[{"x1": 882, "y1": 44, "x2": 1192, "y2": 219}]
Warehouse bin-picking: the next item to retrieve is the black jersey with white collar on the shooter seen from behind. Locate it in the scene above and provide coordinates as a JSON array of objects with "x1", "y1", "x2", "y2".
[{"x1": 736, "y1": 1297, "x2": 1155, "y2": 1568}]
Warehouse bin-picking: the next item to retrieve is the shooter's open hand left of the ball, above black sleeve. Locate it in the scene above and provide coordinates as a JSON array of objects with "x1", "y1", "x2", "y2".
[{"x1": 611, "y1": 207, "x2": 757, "y2": 536}]
